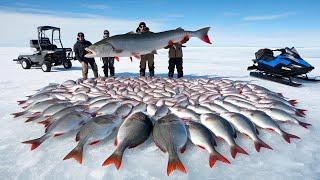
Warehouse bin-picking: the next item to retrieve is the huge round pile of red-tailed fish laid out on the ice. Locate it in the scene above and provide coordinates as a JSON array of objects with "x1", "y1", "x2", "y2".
[{"x1": 12, "y1": 77, "x2": 310, "y2": 175}]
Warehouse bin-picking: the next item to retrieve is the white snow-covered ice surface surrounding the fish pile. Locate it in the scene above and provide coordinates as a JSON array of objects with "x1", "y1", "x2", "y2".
[{"x1": 0, "y1": 47, "x2": 320, "y2": 179}]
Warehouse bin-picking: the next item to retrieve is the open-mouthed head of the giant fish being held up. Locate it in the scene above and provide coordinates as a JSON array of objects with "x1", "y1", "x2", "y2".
[{"x1": 85, "y1": 40, "x2": 114, "y2": 58}]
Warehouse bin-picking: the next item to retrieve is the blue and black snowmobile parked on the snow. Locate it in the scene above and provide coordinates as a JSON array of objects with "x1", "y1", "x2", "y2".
[{"x1": 248, "y1": 47, "x2": 320, "y2": 87}]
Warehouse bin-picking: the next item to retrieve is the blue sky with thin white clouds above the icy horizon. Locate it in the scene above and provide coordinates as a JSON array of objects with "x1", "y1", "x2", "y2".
[{"x1": 0, "y1": 0, "x2": 320, "y2": 47}]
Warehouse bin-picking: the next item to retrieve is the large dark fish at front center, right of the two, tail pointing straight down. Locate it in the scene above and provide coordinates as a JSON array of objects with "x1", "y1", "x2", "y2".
[{"x1": 152, "y1": 114, "x2": 188, "y2": 176}]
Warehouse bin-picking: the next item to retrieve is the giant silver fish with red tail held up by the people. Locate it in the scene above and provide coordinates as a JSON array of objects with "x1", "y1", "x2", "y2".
[{"x1": 85, "y1": 27, "x2": 211, "y2": 58}]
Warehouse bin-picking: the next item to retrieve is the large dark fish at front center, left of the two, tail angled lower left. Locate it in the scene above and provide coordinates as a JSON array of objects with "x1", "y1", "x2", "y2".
[{"x1": 102, "y1": 112, "x2": 152, "y2": 169}]
